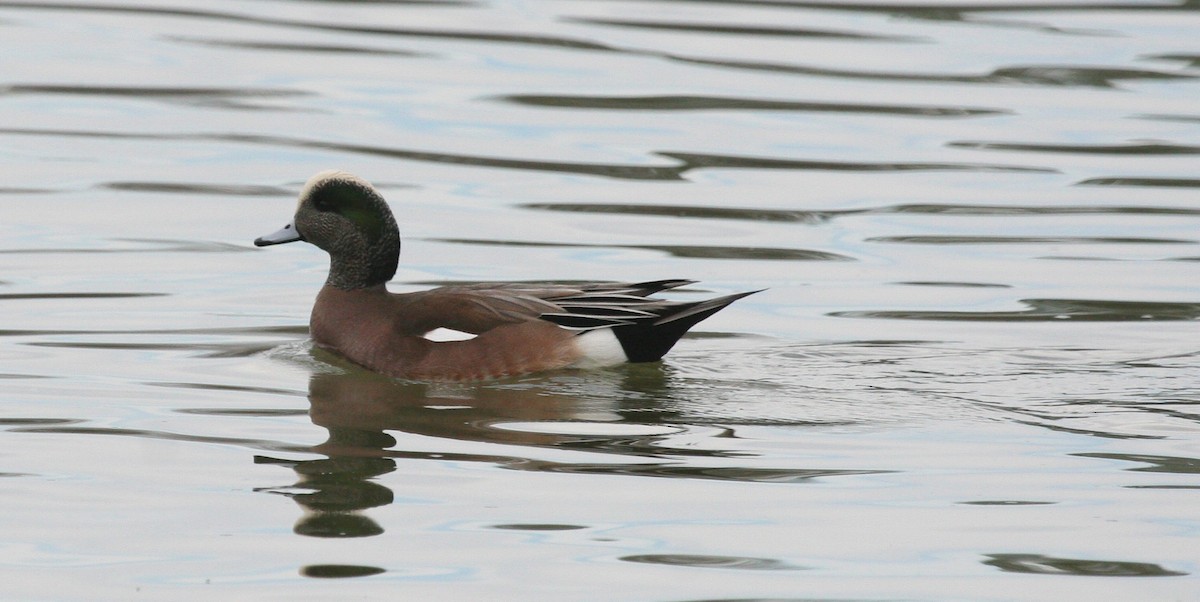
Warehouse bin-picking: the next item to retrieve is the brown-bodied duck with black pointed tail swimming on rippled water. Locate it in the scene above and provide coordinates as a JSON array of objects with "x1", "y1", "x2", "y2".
[{"x1": 254, "y1": 171, "x2": 751, "y2": 380}]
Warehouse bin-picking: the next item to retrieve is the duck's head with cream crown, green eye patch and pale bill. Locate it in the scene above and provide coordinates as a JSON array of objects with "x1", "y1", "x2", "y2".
[{"x1": 254, "y1": 171, "x2": 400, "y2": 290}]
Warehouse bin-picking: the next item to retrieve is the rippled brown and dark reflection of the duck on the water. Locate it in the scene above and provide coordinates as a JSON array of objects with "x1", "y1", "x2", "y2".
[{"x1": 258, "y1": 354, "x2": 881, "y2": 537}]
